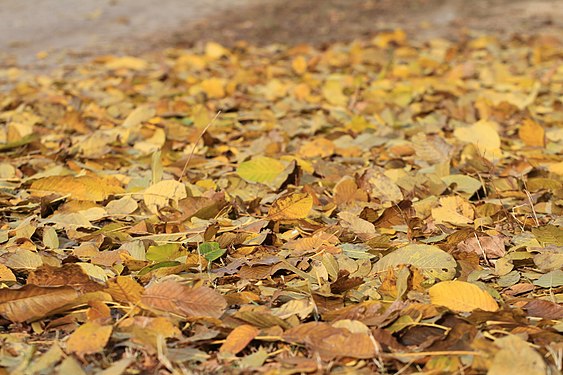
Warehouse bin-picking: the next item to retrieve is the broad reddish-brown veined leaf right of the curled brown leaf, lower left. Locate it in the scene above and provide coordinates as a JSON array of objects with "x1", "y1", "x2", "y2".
[{"x1": 141, "y1": 281, "x2": 227, "y2": 318}]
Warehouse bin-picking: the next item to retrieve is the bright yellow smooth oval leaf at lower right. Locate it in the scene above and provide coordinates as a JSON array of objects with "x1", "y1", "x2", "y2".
[{"x1": 428, "y1": 281, "x2": 498, "y2": 312}]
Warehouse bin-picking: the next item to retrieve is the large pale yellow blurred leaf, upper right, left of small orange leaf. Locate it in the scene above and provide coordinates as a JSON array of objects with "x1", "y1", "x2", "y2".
[{"x1": 454, "y1": 120, "x2": 502, "y2": 160}]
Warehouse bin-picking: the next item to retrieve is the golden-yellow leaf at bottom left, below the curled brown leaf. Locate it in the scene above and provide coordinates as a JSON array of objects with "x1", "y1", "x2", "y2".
[{"x1": 66, "y1": 322, "x2": 113, "y2": 356}]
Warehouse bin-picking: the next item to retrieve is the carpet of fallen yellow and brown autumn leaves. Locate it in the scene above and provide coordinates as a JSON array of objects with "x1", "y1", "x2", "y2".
[{"x1": 0, "y1": 30, "x2": 563, "y2": 374}]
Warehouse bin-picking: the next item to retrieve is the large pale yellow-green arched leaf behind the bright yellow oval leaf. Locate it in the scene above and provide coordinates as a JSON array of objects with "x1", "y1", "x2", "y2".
[{"x1": 374, "y1": 244, "x2": 457, "y2": 280}]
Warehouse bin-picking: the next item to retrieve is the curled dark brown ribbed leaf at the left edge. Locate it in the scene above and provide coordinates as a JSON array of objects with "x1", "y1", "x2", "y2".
[{"x1": 0, "y1": 285, "x2": 78, "y2": 322}]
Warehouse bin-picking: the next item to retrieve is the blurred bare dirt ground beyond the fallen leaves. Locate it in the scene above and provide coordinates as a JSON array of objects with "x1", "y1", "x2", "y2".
[{"x1": 0, "y1": 0, "x2": 563, "y2": 67}]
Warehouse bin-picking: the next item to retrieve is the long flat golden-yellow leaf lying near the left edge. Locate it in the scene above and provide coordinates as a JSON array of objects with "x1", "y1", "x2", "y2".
[{"x1": 31, "y1": 176, "x2": 124, "y2": 201}]
